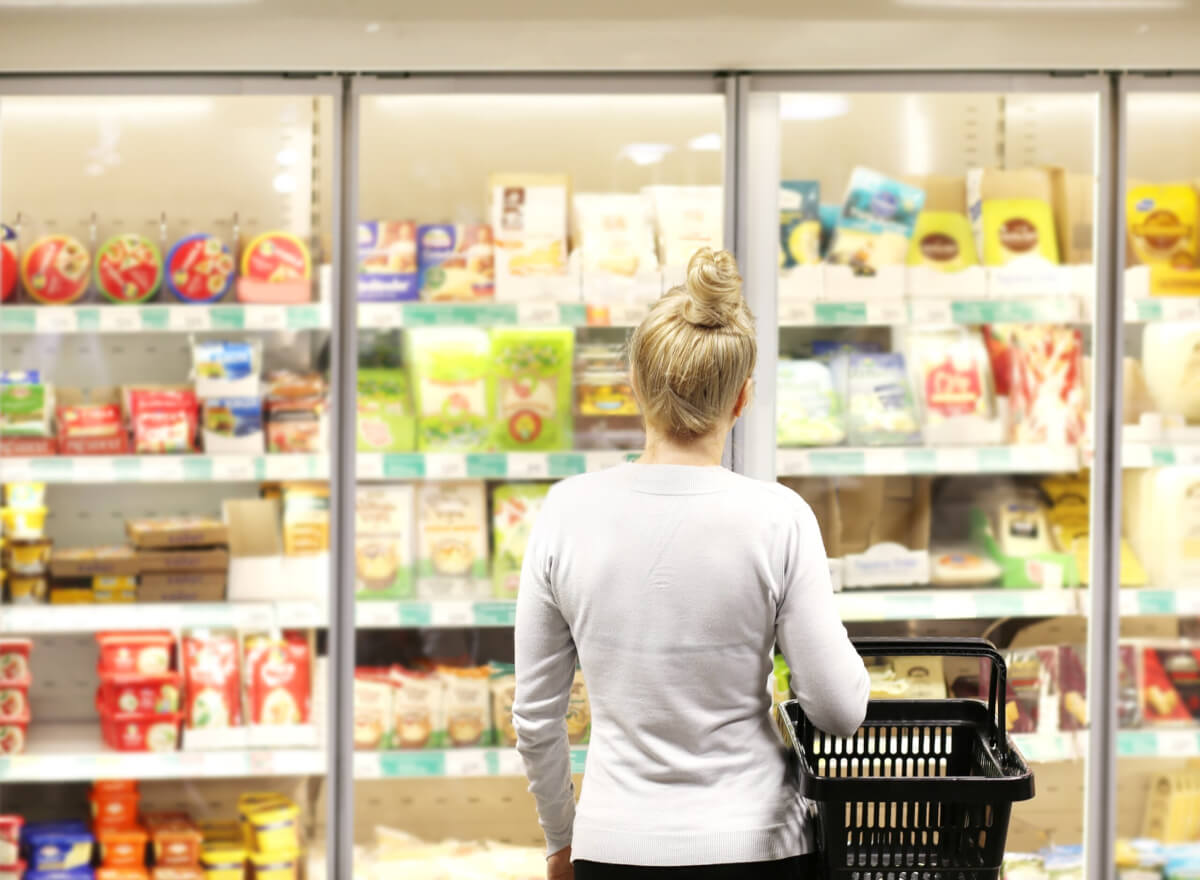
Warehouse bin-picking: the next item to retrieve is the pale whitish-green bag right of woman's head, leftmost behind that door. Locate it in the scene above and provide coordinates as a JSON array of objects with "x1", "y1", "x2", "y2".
[{"x1": 775, "y1": 360, "x2": 846, "y2": 447}]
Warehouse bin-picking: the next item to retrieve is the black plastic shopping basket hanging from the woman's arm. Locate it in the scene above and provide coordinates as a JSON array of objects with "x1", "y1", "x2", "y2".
[{"x1": 779, "y1": 639, "x2": 1033, "y2": 880}]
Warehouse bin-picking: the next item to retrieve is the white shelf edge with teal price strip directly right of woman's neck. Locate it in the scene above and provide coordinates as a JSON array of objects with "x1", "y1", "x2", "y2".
[{"x1": 775, "y1": 445, "x2": 1080, "y2": 477}]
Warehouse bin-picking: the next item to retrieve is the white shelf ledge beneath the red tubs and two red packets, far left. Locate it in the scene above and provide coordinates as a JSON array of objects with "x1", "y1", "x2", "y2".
[{"x1": 0, "y1": 722, "x2": 325, "y2": 784}]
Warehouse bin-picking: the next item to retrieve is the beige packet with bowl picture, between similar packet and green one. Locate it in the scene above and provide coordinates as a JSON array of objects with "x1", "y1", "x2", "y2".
[{"x1": 416, "y1": 481, "x2": 487, "y2": 579}]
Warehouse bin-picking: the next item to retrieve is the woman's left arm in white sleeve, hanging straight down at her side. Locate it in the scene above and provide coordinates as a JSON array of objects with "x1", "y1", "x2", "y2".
[{"x1": 512, "y1": 498, "x2": 575, "y2": 854}]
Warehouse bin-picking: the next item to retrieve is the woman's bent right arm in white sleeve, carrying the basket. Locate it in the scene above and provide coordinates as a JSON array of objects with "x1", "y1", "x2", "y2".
[{"x1": 775, "y1": 502, "x2": 871, "y2": 736}]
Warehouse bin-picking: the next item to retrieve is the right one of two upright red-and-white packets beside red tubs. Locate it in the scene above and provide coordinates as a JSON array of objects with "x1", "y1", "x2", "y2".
[{"x1": 246, "y1": 633, "x2": 312, "y2": 724}]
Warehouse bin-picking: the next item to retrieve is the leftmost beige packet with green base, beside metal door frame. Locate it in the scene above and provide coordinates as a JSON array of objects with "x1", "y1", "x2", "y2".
[{"x1": 354, "y1": 485, "x2": 415, "y2": 599}]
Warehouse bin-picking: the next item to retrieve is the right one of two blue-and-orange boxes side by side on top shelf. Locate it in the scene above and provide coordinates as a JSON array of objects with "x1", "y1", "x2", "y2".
[{"x1": 416, "y1": 223, "x2": 496, "y2": 303}]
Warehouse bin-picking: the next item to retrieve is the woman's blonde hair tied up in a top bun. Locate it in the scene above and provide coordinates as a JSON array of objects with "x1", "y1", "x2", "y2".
[{"x1": 629, "y1": 247, "x2": 758, "y2": 441}]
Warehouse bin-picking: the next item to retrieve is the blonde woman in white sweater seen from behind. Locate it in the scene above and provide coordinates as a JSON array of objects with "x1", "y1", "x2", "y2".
[{"x1": 512, "y1": 249, "x2": 869, "y2": 880}]
